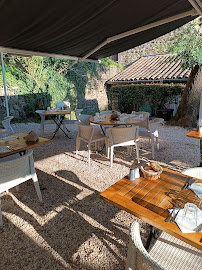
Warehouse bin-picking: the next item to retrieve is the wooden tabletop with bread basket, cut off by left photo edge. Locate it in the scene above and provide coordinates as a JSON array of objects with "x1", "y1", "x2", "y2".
[{"x1": 0, "y1": 133, "x2": 50, "y2": 158}]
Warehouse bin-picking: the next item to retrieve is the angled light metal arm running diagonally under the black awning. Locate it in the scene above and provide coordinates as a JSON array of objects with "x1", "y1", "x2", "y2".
[{"x1": 80, "y1": 9, "x2": 197, "y2": 61}]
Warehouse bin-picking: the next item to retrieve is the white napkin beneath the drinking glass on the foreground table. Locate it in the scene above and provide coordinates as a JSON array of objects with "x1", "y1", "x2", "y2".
[{"x1": 169, "y1": 207, "x2": 202, "y2": 233}]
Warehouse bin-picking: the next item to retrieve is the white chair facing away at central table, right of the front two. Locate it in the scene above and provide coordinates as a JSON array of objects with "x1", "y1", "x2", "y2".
[{"x1": 107, "y1": 126, "x2": 140, "y2": 167}]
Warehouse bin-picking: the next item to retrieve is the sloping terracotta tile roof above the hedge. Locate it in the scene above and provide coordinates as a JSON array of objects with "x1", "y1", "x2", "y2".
[{"x1": 108, "y1": 54, "x2": 190, "y2": 83}]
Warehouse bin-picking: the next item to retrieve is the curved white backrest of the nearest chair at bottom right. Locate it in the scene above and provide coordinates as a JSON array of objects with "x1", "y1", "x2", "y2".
[{"x1": 125, "y1": 221, "x2": 164, "y2": 270}]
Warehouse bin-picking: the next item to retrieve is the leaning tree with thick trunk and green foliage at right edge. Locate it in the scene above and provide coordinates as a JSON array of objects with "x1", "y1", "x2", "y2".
[{"x1": 159, "y1": 17, "x2": 202, "y2": 127}]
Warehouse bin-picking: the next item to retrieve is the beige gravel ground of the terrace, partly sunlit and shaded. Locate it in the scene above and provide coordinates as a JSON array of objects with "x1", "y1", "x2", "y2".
[{"x1": 0, "y1": 123, "x2": 200, "y2": 270}]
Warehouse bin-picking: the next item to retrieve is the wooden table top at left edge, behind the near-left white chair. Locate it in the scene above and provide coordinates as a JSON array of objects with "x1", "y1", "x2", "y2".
[{"x1": 0, "y1": 133, "x2": 50, "y2": 158}]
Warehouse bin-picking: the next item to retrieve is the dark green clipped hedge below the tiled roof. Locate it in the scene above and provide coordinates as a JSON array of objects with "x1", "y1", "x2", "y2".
[{"x1": 108, "y1": 84, "x2": 184, "y2": 115}]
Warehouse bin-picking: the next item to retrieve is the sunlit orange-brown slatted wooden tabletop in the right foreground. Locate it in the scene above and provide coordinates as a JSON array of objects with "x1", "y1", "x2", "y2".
[{"x1": 100, "y1": 169, "x2": 202, "y2": 250}]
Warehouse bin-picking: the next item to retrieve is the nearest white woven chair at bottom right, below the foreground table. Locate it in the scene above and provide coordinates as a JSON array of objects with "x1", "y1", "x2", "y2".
[{"x1": 125, "y1": 221, "x2": 202, "y2": 270}]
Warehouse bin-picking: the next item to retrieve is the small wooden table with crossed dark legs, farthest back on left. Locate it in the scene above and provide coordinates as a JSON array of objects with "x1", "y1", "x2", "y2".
[{"x1": 38, "y1": 109, "x2": 71, "y2": 140}]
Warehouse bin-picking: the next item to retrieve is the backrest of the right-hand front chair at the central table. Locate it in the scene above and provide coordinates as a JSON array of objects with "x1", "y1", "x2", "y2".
[{"x1": 108, "y1": 126, "x2": 139, "y2": 145}]
